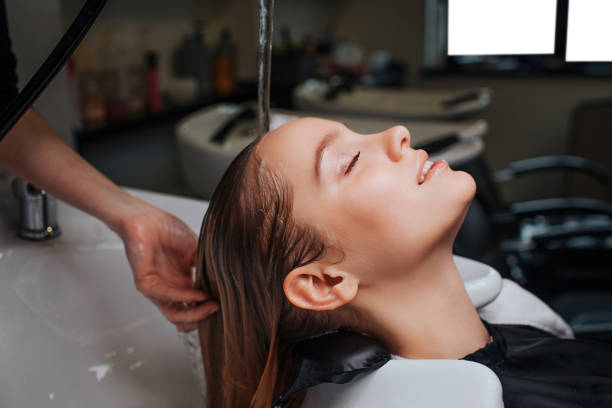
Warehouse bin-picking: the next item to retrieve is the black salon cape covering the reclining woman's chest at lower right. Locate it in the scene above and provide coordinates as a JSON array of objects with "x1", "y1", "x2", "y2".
[{"x1": 463, "y1": 322, "x2": 612, "y2": 408}]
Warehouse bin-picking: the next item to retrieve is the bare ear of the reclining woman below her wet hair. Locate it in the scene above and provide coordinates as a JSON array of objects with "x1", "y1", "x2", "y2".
[{"x1": 283, "y1": 262, "x2": 359, "y2": 310}]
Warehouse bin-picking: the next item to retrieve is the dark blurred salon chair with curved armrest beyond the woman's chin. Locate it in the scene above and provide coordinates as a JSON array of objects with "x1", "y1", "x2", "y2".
[{"x1": 455, "y1": 156, "x2": 612, "y2": 342}]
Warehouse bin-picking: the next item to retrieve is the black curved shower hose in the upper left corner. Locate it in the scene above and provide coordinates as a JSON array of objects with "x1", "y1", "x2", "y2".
[{"x1": 0, "y1": 0, "x2": 106, "y2": 141}]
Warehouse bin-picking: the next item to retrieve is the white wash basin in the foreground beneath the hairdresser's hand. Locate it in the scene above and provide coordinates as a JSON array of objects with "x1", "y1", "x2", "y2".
[{"x1": 0, "y1": 186, "x2": 206, "y2": 408}]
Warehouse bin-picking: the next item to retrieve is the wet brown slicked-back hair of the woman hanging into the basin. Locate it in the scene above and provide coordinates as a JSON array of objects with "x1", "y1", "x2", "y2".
[{"x1": 197, "y1": 138, "x2": 340, "y2": 408}]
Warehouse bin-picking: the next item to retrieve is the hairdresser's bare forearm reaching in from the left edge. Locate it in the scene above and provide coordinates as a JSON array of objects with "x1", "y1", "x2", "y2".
[{"x1": 0, "y1": 109, "x2": 146, "y2": 235}]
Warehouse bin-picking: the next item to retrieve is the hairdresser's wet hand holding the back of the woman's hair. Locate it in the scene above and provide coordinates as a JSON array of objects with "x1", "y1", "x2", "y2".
[{"x1": 119, "y1": 204, "x2": 218, "y2": 331}]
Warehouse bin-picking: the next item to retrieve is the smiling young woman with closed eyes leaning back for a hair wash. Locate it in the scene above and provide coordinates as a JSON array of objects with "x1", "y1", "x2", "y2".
[{"x1": 198, "y1": 118, "x2": 612, "y2": 408}]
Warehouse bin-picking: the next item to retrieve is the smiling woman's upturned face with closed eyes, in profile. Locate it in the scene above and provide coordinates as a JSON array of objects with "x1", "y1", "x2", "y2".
[{"x1": 257, "y1": 118, "x2": 476, "y2": 285}]
